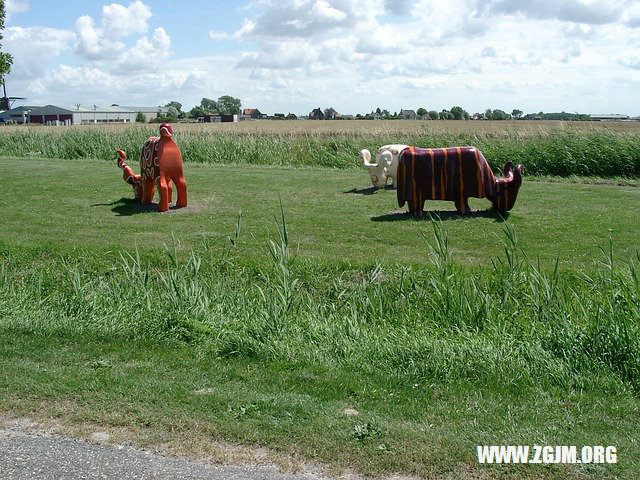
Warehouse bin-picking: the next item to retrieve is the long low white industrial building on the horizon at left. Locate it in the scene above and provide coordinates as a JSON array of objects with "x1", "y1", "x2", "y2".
[{"x1": 0, "y1": 104, "x2": 169, "y2": 125}]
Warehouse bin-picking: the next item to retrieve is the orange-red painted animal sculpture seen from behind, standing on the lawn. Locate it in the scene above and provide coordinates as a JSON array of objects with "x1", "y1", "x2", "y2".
[{"x1": 118, "y1": 123, "x2": 187, "y2": 212}]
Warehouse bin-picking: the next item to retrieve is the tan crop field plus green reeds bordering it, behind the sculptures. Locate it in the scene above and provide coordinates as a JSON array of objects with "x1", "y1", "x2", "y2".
[{"x1": 0, "y1": 121, "x2": 640, "y2": 178}]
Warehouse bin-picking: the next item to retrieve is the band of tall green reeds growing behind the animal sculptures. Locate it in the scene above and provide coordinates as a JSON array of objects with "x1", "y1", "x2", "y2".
[{"x1": 0, "y1": 128, "x2": 640, "y2": 178}]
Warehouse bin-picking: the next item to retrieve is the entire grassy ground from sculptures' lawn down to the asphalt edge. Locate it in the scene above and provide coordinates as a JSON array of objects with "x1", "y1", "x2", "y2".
[{"x1": 0, "y1": 158, "x2": 640, "y2": 478}]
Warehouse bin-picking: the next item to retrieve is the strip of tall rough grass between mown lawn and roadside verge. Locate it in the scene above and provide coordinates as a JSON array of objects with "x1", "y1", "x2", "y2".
[{"x1": 0, "y1": 216, "x2": 640, "y2": 390}]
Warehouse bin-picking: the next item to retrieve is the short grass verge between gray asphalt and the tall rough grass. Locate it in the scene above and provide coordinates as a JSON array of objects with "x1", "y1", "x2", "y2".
[{"x1": 0, "y1": 330, "x2": 640, "y2": 479}]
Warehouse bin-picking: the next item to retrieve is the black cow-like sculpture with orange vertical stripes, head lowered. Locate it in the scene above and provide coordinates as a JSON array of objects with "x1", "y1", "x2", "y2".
[{"x1": 397, "y1": 147, "x2": 522, "y2": 216}]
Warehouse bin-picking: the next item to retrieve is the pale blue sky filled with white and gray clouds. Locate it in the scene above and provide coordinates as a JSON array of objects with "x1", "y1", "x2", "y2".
[{"x1": 3, "y1": 0, "x2": 640, "y2": 116}]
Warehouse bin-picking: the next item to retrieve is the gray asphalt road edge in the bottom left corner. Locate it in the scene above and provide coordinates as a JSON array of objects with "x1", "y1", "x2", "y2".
[{"x1": 0, "y1": 428, "x2": 323, "y2": 480}]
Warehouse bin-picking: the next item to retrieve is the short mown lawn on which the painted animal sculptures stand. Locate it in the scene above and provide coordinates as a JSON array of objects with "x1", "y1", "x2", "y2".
[{"x1": 0, "y1": 159, "x2": 640, "y2": 267}]
